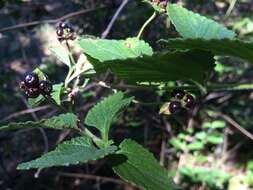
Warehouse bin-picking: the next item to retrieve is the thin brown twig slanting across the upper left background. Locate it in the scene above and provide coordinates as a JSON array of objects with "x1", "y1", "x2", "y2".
[{"x1": 0, "y1": 6, "x2": 105, "y2": 32}]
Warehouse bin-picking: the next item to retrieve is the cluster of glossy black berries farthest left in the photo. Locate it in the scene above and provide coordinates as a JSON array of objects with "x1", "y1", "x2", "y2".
[{"x1": 20, "y1": 73, "x2": 53, "y2": 98}]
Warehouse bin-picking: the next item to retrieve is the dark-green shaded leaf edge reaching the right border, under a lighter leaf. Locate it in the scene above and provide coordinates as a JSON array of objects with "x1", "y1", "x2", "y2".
[{"x1": 161, "y1": 39, "x2": 253, "y2": 63}]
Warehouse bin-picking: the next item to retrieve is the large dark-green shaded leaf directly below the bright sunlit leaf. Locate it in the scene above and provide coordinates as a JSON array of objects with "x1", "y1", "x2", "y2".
[{"x1": 89, "y1": 51, "x2": 215, "y2": 83}]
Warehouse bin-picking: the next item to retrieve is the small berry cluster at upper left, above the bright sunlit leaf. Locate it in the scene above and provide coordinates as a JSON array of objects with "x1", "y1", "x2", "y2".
[{"x1": 56, "y1": 22, "x2": 76, "y2": 42}]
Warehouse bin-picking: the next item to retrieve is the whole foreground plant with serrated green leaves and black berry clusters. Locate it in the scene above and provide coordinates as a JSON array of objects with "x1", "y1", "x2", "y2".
[{"x1": 0, "y1": 0, "x2": 253, "y2": 190}]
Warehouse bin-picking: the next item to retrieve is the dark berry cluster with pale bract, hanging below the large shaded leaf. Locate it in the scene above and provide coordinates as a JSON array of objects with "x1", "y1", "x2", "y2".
[{"x1": 160, "y1": 90, "x2": 196, "y2": 115}]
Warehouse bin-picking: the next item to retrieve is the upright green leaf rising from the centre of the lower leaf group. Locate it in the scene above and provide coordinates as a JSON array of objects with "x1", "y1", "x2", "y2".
[{"x1": 85, "y1": 92, "x2": 133, "y2": 140}]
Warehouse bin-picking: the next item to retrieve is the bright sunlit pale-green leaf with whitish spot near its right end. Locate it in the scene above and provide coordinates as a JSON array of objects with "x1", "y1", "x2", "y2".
[{"x1": 78, "y1": 38, "x2": 153, "y2": 62}]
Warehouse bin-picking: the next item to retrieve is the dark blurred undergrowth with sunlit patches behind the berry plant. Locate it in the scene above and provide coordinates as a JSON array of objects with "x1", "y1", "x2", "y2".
[{"x1": 0, "y1": 0, "x2": 253, "y2": 190}]
